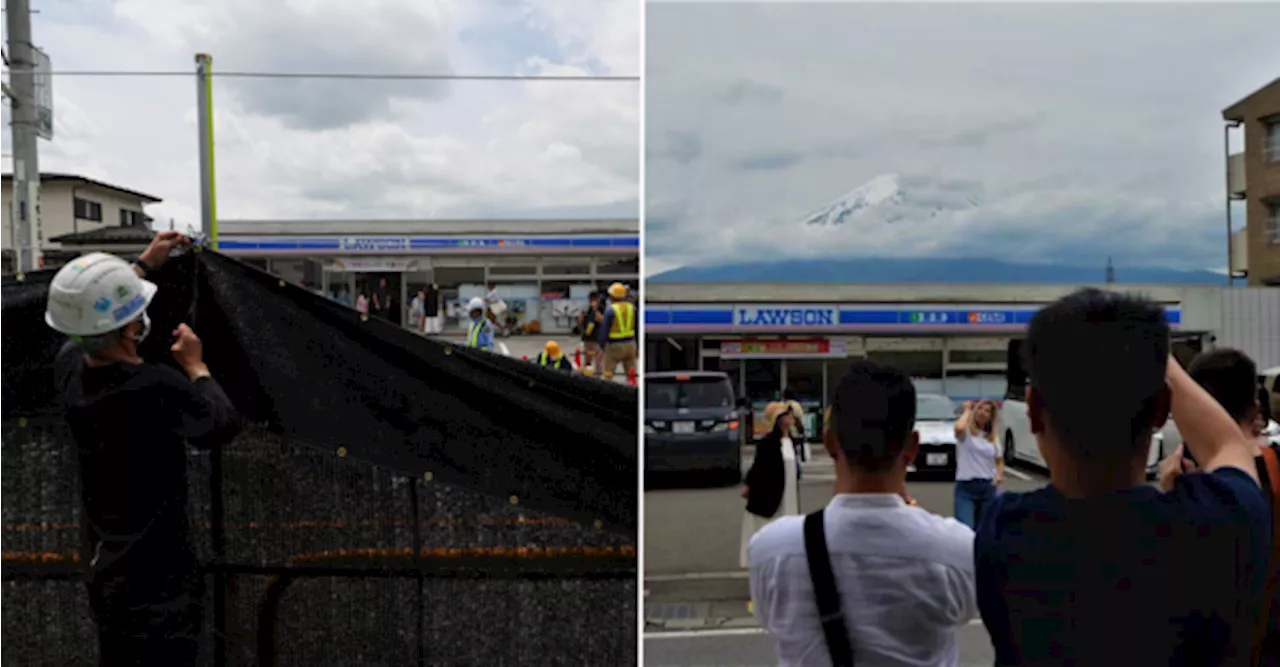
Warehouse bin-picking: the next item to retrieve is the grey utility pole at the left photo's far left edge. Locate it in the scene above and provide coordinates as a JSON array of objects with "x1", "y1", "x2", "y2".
[{"x1": 5, "y1": 0, "x2": 44, "y2": 271}]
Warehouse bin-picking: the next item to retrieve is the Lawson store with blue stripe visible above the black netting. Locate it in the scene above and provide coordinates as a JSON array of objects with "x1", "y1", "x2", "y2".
[{"x1": 219, "y1": 219, "x2": 640, "y2": 334}]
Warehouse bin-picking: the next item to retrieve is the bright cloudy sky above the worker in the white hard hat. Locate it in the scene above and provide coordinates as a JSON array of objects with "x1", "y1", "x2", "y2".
[{"x1": 10, "y1": 0, "x2": 640, "y2": 228}]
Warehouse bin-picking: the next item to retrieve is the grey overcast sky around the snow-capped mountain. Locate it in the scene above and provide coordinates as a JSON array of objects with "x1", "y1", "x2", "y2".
[{"x1": 645, "y1": 1, "x2": 1280, "y2": 274}]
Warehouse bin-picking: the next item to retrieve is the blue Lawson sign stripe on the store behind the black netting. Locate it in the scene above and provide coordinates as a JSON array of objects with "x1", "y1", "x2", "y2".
[{"x1": 218, "y1": 234, "x2": 640, "y2": 255}]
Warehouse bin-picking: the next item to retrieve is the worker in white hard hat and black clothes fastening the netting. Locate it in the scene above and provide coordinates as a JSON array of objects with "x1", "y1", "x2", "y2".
[{"x1": 45, "y1": 232, "x2": 239, "y2": 667}]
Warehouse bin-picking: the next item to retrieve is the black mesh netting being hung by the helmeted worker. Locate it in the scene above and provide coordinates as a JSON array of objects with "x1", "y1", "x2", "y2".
[{"x1": 0, "y1": 251, "x2": 637, "y2": 666}]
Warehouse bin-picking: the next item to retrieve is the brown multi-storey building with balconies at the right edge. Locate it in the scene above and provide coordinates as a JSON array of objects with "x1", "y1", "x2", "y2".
[{"x1": 1222, "y1": 79, "x2": 1280, "y2": 287}]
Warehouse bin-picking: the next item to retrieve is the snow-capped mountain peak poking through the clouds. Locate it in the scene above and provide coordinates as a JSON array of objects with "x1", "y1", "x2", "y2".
[{"x1": 804, "y1": 174, "x2": 983, "y2": 227}]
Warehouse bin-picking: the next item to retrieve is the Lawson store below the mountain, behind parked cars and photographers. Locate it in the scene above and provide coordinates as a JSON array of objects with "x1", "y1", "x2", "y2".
[{"x1": 644, "y1": 283, "x2": 1202, "y2": 433}]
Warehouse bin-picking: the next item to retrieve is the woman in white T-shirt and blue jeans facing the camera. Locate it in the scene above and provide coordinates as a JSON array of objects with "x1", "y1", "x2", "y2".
[{"x1": 955, "y1": 401, "x2": 1005, "y2": 530}]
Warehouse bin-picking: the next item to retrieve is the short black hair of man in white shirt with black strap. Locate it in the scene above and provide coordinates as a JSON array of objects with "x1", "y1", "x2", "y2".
[{"x1": 831, "y1": 360, "x2": 915, "y2": 472}]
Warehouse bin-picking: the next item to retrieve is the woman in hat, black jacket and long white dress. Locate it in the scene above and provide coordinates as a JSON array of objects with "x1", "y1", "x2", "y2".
[{"x1": 739, "y1": 403, "x2": 800, "y2": 568}]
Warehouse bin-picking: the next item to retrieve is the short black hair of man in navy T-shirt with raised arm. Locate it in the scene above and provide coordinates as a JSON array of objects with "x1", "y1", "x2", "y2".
[{"x1": 1023, "y1": 288, "x2": 1169, "y2": 462}]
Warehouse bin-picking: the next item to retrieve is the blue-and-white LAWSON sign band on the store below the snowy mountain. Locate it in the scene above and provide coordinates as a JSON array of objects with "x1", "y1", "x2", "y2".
[{"x1": 644, "y1": 303, "x2": 1181, "y2": 333}]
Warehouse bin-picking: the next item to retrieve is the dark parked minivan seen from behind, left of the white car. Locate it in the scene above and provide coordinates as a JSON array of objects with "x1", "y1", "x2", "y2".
[{"x1": 644, "y1": 371, "x2": 745, "y2": 484}]
